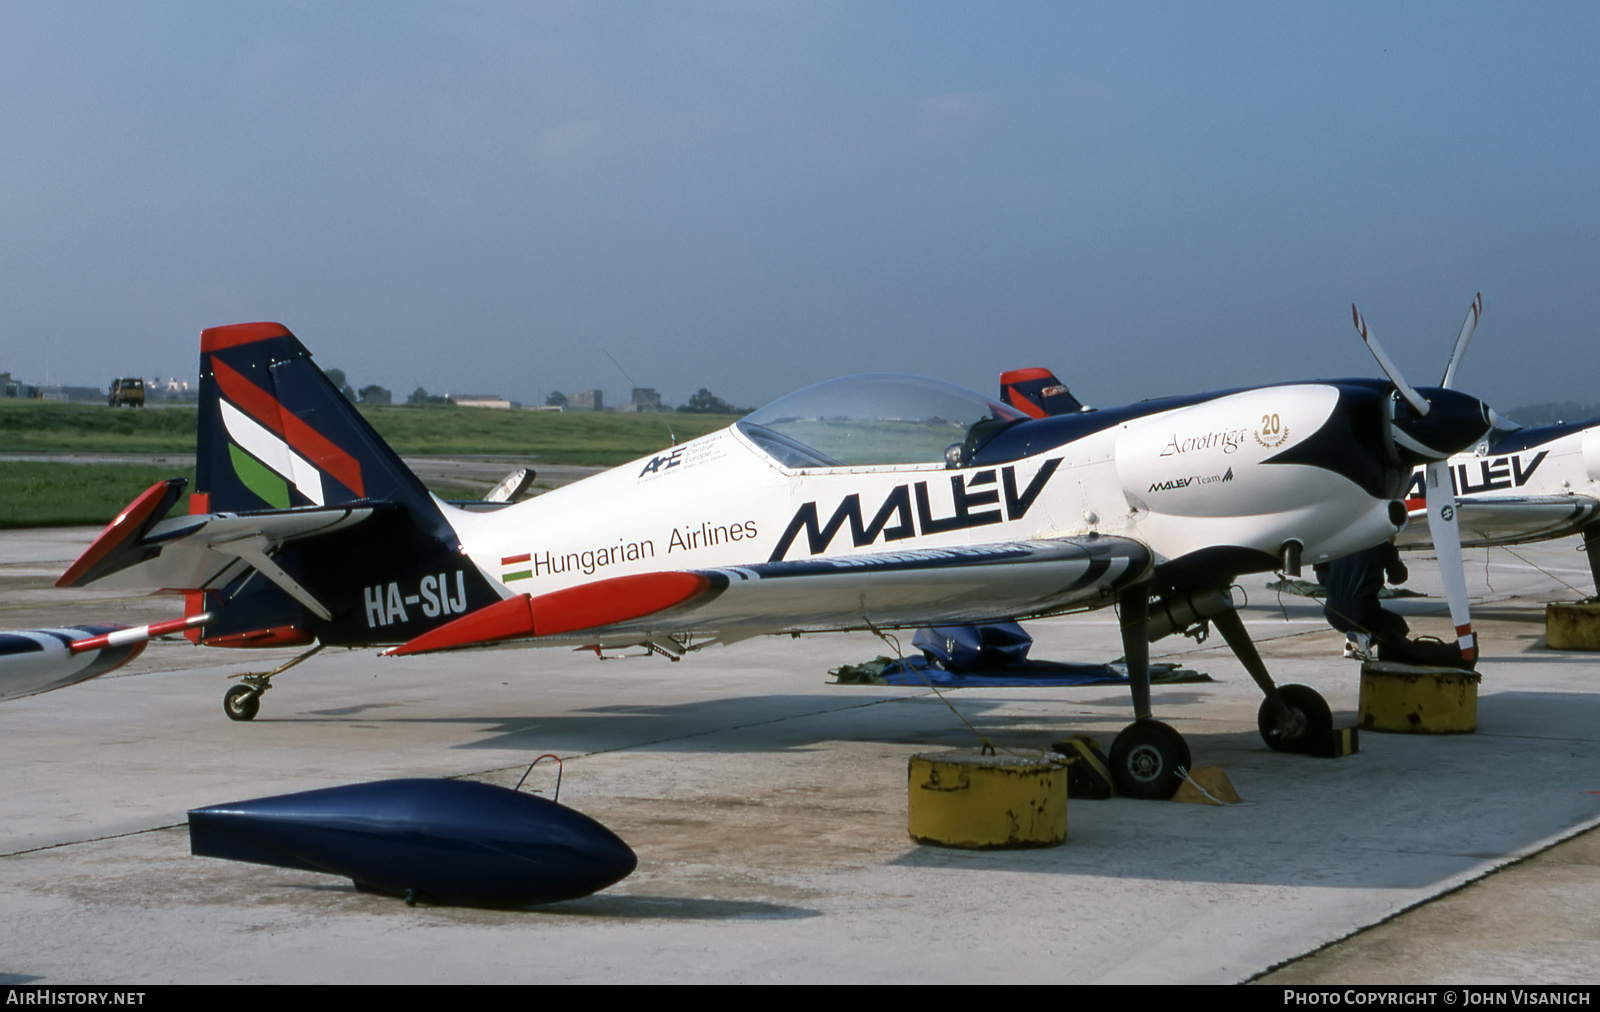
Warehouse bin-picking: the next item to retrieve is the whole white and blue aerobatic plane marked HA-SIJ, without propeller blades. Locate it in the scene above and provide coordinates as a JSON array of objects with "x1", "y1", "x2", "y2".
[{"x1": 59, "y1": 323, "x2": 1490, "y2": 797}]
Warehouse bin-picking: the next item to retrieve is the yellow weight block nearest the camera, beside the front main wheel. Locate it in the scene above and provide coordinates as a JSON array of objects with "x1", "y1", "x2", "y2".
[{"x1": 906, "y1": 749, "x2": 1067, "y2": 849}]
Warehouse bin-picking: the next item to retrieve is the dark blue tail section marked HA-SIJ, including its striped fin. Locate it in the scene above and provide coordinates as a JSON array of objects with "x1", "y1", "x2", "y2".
[{"x1": 175, "y1": 323, "x2": 498, "y2": 645}]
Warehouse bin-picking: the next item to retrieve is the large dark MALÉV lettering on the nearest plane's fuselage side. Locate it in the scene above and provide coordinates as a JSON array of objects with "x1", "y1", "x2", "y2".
[{"x1": 768, "y1": 456, "x2": 1061, "y2": 562}]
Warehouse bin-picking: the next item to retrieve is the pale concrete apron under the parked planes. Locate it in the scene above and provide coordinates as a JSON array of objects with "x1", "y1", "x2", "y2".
[{"x1": 0, "y1": 532, "x2": 1600, "y2": 983}]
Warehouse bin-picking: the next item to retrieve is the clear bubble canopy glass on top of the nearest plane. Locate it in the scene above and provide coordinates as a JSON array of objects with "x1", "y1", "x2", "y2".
[{"x1": 738, "y1": 373, "x2": 1024, "y2": 468}]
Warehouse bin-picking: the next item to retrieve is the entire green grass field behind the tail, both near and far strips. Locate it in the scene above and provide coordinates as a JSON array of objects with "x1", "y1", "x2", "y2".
[{"x1": 0, "y1": 400, "x2": 733, "y2": 527}]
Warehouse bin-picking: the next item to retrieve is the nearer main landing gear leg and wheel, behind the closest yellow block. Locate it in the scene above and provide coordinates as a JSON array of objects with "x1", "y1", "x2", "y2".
[{"x1": 1110, "y1": 588, "x2": 1190, "y2": 799}]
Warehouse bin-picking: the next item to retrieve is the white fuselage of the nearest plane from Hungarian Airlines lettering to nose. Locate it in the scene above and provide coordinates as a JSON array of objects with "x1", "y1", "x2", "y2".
[{"x1": 448, "y1": 383, "x2": 1403, "y2": 596}]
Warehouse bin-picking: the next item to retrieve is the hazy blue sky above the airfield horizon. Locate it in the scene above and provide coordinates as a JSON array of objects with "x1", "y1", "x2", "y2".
[{"x1": 0, "y1": 2, "x2": 1600, "y2": 407}]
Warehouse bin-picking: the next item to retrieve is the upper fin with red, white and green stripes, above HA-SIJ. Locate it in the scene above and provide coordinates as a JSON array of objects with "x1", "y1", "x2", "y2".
[{"x1": 190, "y1": 323, "x2": 437, "y2": 514}]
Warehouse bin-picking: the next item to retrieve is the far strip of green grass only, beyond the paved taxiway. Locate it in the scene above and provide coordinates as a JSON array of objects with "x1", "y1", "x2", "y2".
[{"x1": 0, "y1": 400, "x2": 733, "y2": 466}]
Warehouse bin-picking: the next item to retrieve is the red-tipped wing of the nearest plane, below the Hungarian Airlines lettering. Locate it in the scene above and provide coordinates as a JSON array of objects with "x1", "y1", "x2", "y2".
[{"x1": 389, "y1": 536, "x2": 1154, "y2": 653}]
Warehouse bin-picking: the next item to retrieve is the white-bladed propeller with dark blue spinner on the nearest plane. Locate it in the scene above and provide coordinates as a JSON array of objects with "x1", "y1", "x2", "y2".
[{"x1": 1350, "y1": 293, "x2": 1490, "y2": 666}]
